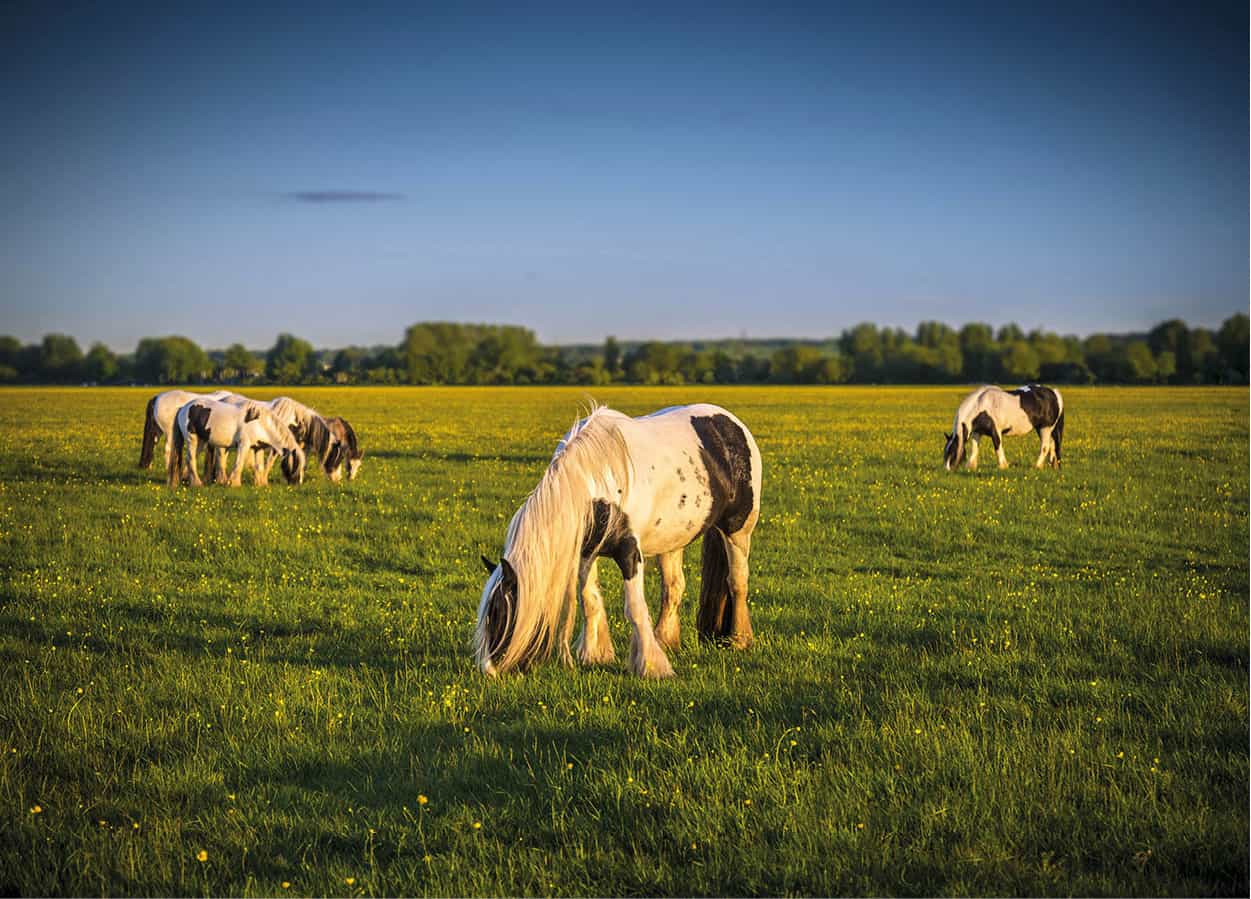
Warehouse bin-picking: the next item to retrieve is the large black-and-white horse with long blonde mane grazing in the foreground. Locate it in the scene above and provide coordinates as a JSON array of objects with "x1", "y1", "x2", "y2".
[{"x1": 475, "y1": 404, "x2": 761, "y2": 678}]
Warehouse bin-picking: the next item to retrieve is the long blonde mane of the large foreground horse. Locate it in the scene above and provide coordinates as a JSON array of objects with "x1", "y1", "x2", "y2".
[{"x1": 477, "y1": 406, "x2": 633, "y2": 671}]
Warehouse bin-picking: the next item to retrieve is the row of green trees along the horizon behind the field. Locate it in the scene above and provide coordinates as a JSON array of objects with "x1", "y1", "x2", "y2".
[{"x1": 0, "y1": 313, "x2": 1248, "y2": 385}]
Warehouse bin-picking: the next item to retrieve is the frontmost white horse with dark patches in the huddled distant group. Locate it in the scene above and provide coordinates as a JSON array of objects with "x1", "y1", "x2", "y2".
[{"x1": 168, "y1": 398, "x2": 304, "y2": 488}]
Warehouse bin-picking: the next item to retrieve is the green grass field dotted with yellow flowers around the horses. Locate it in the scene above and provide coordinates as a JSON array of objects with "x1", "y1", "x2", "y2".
[{"x1": 0, "y1": 388, "x2": 1248, "y2": 895}]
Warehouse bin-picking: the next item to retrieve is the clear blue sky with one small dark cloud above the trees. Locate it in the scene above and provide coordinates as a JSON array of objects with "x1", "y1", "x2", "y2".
[{"x1": 0, "y1": 3, "x2": 1248, "y2": 350}]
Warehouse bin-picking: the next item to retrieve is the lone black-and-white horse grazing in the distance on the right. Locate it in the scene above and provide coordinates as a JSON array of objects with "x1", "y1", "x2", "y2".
[{"x1": 943, "y1": 384, "x2": 1065, "y2": 471}]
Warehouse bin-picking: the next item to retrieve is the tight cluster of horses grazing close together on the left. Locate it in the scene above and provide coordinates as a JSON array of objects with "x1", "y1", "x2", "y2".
[{"x1": 139, "y1": 390, "x2": 364, "y2": 488}]
